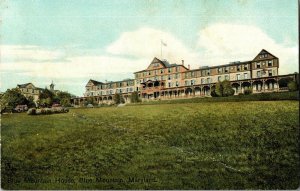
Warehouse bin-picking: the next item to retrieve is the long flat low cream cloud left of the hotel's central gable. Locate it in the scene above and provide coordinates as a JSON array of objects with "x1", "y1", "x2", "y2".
[{"x1": 1, "y1": 56, "x2": 146, "y2": 79}]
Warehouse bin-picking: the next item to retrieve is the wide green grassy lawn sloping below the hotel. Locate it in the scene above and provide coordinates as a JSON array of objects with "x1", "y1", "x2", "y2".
[{"x1": 1, "y1": 101, "x2": 300, "y2": 189}]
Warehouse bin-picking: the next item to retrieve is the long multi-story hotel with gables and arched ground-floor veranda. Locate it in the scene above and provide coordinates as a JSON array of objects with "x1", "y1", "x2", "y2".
[{"x1": 72, "y1": 49, "x2": 298, "y2": 105}]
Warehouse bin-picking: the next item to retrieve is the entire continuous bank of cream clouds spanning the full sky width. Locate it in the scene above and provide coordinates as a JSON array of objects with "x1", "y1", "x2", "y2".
[{"x1": 0, "y1": 23, "x2": 298, "y2": 94}]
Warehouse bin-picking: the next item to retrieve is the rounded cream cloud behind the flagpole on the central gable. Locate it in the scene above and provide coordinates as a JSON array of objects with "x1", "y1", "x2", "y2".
[{"x1": 106, "y1": 27, "x2": 199, "y2": 64}]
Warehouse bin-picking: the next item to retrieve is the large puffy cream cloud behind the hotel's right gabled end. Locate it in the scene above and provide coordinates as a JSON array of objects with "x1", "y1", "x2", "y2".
[{"x1": 197, "y1": 23, "x2": 299, "y2": 74}]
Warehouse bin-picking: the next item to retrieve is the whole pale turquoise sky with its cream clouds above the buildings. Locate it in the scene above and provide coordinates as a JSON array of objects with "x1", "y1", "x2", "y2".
[{"x1": 0, "y1": 0, "x2": 299, "y2": 96}]
